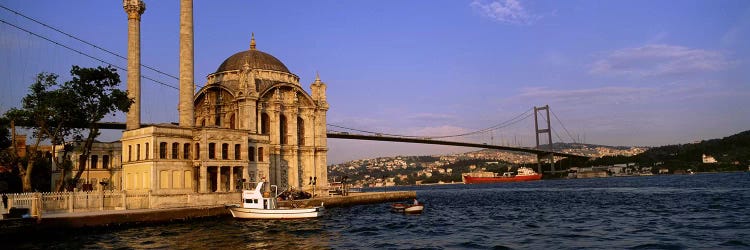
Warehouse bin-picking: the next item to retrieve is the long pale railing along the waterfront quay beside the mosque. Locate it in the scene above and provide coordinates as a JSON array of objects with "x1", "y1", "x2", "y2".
[{"x1": 0, "y1": 190, "x2": 241, "y2": 217}]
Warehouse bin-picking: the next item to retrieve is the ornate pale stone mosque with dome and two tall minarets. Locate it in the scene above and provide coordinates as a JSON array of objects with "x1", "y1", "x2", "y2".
[{"x1": 121, "y1": 0, "x2": 328, "y2": 194}]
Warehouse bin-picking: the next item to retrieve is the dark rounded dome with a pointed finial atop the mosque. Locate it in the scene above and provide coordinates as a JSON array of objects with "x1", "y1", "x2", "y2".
[{"x1": 216, "y1": 35, "x2": 291, "y2": 73}]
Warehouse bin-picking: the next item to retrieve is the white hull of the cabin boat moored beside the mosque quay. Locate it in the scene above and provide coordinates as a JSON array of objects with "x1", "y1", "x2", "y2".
[{"x1": 227, "y1": 206, "x2": 324, "y2": 219}]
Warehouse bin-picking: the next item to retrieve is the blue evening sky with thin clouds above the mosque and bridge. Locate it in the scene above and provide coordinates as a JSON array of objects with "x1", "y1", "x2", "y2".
[{"x1": 0, "y1": 0, "x2": 750, "y2": 163}]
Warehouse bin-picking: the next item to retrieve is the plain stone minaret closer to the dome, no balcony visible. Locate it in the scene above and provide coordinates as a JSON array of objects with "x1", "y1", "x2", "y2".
[{"x1": 179, "y1": 0, "x2": 195, "y2": 128}]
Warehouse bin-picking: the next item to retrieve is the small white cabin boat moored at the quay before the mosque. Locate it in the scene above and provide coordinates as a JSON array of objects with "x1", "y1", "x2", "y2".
[{"x1": 226, "y1": 182, "x2": 324, "y2": 219}]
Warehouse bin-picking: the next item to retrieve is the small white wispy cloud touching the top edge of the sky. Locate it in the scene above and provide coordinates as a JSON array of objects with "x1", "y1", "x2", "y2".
[{"x1": 470, "y1": 0, "x2": 539, "y2": 24}]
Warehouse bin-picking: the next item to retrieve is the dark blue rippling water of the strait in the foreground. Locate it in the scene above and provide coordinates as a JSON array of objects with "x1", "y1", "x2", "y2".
[{"x1": 3, "y1": 173, "x2": 750, "y2": 249}]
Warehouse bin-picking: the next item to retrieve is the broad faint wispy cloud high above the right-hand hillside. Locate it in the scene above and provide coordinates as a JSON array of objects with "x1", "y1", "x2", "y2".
[{"x1": 589, "y1": 44, "x2": 730, "y2": 77}]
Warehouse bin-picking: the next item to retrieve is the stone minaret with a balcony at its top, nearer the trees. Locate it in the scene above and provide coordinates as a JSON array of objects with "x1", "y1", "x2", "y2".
[{"x1": 122, "y1": 0, "x2": 146, "y2": 130}]
